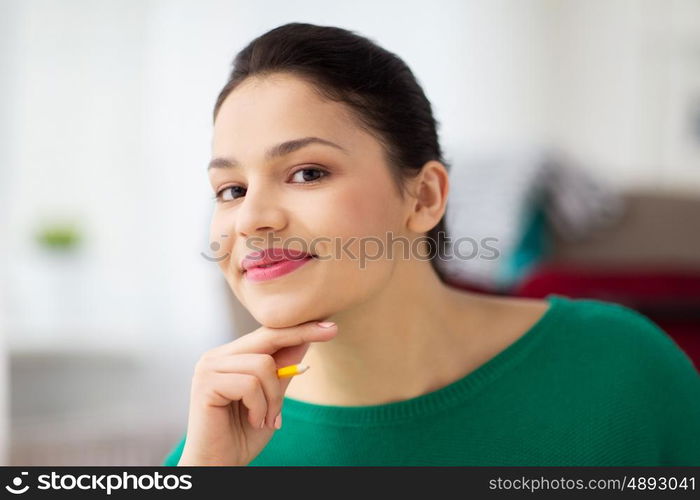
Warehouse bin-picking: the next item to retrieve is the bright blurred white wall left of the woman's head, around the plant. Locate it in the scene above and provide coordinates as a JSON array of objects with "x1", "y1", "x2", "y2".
[{"x1": 3, "y1": 1, "x2": 237, "y2": 360}]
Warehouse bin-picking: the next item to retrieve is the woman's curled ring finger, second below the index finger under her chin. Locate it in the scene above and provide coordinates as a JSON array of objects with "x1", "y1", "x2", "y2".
[{"x1": 208, "y1": 372, "x2": 267, "y2": 429}]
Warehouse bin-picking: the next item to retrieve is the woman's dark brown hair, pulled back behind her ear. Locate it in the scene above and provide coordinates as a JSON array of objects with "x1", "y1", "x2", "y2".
[{"x1": 214, "y1": 23, "x2": 450, "y2": 281}]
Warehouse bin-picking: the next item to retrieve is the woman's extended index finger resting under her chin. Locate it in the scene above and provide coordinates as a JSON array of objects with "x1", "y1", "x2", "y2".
[{"x1": 222, "y1": 322, "x2": 338, "y2": 354}]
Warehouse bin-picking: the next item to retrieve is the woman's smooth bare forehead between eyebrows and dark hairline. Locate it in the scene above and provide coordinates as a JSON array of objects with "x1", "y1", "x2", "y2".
[{"x1": 212, "y1": 74, "x2": 368, "y2": 155}]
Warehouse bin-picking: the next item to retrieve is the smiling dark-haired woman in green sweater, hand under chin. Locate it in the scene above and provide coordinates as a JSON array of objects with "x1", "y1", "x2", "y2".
[{"x1": 164, "y1": 23, "x2": 700, "y2": 465}]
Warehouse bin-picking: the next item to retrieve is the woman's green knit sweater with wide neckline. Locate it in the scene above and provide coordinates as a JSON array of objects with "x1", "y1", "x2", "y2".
[{"x1": 163, "y1": 294, "x2": 700, "y2": 466}]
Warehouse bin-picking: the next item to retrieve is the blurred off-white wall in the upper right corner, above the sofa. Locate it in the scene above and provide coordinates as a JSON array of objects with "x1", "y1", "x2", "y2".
[{"x1": 549, "y1": 0, "x2": 700, "y2": 193}]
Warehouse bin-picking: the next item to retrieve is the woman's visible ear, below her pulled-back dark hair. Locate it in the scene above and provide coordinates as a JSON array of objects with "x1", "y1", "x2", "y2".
[{"x1": 406, "y1": 160, "x2": 450, "y2": 233}]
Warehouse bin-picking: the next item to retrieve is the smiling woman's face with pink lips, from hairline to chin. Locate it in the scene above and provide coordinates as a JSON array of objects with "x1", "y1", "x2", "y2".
[{"x1": 209, "y1": 74, "x2": 409, "y2": 328}]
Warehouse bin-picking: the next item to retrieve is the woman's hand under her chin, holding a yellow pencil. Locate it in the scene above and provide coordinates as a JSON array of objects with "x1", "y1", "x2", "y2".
[{"x1": 178, "y1": 321, "x2": 338, "y2": 466}]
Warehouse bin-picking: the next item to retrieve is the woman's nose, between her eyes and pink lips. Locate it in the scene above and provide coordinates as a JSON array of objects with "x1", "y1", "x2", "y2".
[{"x1": 235, "y1": 184, "x2": 286, "y2": 237}]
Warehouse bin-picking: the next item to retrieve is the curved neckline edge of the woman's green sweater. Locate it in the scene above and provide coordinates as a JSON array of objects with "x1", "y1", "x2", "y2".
[{"x1": 282, "y1": 294, "x2": 569, "y2": 426}]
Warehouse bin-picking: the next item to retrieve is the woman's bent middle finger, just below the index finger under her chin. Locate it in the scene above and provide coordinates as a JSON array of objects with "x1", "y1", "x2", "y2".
[{"x1": 208, "y1": 353, "x2": 283, "y2": 428}]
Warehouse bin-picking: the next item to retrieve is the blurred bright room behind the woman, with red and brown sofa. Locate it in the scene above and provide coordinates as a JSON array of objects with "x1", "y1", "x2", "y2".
[{"x1": 0, "y1": 0, "x2": 700, "y2": 465}]
